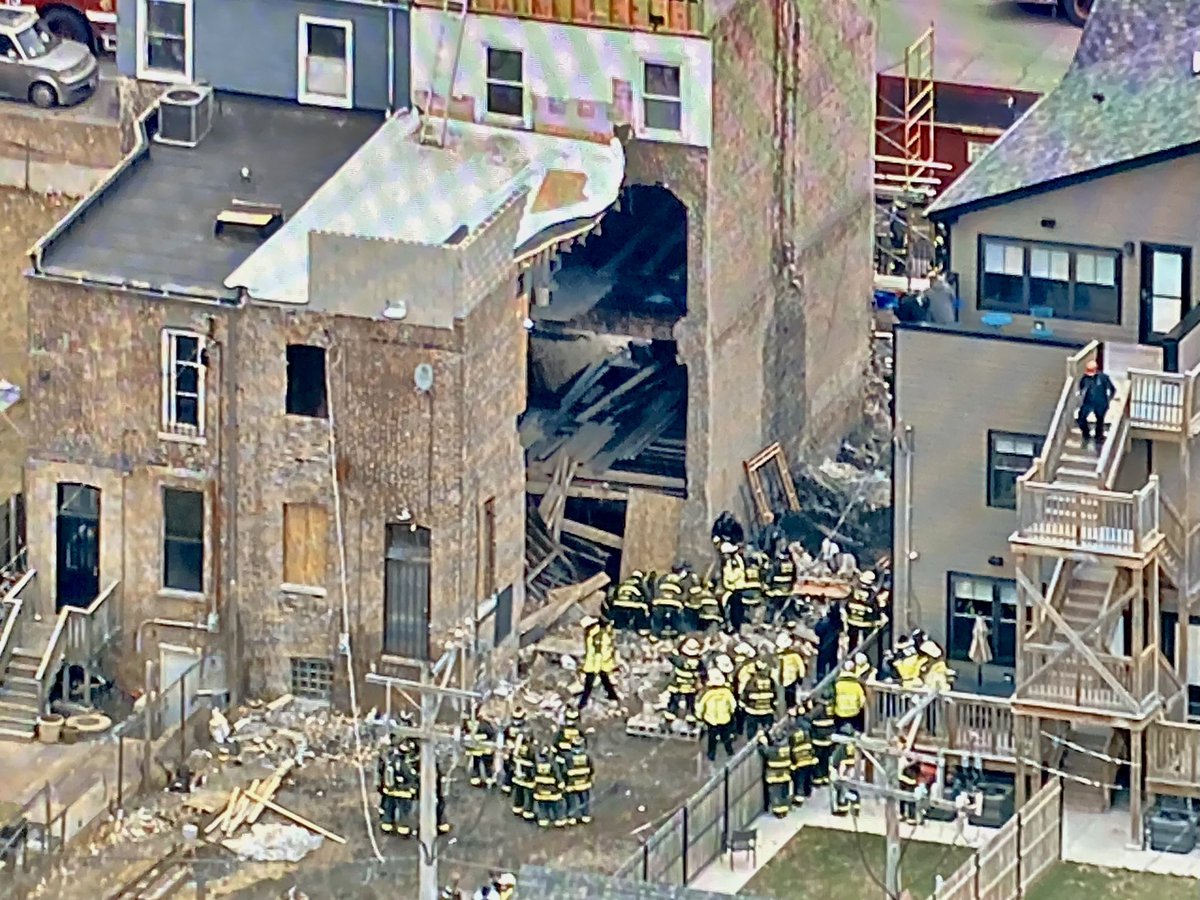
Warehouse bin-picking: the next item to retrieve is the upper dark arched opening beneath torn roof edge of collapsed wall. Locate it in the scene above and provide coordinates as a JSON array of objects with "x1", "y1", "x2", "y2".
[{"x1": 549, "y1": 185, "x2": 688, "y2": 322}]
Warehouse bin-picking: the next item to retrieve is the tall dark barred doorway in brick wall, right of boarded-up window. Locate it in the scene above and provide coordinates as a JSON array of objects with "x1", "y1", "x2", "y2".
[{"x1": 383, "y1": 524, "x2": 431, "y2": 660}]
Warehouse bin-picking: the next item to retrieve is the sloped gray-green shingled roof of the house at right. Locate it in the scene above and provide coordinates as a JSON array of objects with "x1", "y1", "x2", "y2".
[{"x1": 929, "y1": 0, "x2": 1200, "y2": 218}]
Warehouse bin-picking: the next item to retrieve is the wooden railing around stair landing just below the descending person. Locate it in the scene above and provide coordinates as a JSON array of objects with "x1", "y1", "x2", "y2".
[{"x1": 1009, "y1": 475, "x2": 1160, "y2": 556}]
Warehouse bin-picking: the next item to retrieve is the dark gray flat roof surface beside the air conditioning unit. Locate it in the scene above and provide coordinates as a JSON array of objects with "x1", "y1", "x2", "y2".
[{"x1": 38, "y1": 94, "x2": 383, "y2": 298}]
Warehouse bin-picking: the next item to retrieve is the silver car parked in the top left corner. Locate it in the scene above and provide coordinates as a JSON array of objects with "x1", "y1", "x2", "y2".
[{"x1": 0, "y1": 7, "x2": 100, "y2": 109}]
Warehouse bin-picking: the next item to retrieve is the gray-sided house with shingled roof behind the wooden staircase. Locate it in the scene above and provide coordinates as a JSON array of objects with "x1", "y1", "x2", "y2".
[{"x1": 894, "y1": 0, "x2": 1200, "y2": 696}]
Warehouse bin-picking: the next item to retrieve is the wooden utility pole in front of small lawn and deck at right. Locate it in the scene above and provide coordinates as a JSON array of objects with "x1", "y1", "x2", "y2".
[{"x1": 833, "y1": 691, "x2": 956, "y2": 900}]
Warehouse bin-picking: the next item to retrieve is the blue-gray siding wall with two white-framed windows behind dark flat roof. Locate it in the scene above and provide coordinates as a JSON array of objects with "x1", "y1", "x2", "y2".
[{"x1": 116, "y1": 0, "x2": 410, "y2": 110}]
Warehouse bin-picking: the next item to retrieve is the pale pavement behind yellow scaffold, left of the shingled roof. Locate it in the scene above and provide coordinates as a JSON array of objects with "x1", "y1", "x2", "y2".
[{"x1": 876, "y1": 0, "x2": 1082, "y2": 94}]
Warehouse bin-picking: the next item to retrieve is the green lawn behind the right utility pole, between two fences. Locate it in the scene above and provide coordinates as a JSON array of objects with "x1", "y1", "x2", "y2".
[{"x1": 739, "y1": 828, "x2": 974, "y2": 900}]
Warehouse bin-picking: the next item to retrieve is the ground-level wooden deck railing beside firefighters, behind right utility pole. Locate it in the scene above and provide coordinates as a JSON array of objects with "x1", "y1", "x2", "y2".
[{"x1": 866, "y1": 682, "x2": 1015, "y2": 758}]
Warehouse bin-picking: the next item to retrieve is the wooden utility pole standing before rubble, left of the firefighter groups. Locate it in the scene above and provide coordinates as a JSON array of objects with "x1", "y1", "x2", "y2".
[{"x1": 366, "y1": 646, "x2": 482, "y2": 900}]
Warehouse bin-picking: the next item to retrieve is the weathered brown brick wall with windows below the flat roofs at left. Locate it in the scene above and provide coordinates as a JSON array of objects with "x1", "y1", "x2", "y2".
[{"x1": 26, "y1": 255, "x2": 526, "y2": 694}]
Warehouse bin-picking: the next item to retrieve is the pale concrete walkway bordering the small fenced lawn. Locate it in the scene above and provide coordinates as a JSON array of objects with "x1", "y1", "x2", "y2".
[{"x1": 688, "y1": 787, "x2": 996, "y2": 895}]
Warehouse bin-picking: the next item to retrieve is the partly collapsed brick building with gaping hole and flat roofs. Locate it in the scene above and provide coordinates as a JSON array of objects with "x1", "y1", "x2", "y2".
[{"x1": 7, "y1": 0, "x2": 874, "y2": 710}]
